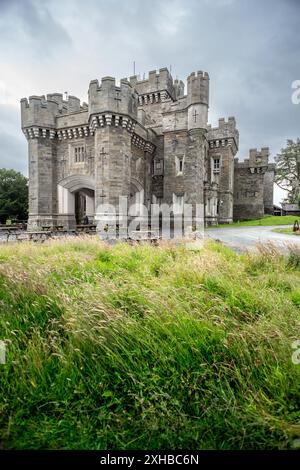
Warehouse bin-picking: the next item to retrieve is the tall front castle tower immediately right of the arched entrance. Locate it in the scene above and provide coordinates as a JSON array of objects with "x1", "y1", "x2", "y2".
[{"x1": 89, "y1": 77, "x2": 137, "y2": 226}]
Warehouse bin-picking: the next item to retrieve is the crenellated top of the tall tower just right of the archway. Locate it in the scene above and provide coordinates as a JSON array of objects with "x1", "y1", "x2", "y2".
[{"x1": 88, "y1": 77, "x2": 138, "y2": 119}]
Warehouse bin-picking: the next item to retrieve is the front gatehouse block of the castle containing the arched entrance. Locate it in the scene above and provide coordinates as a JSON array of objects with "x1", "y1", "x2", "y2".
[{"x1": 21, "y1": 77, "x2": 156, "y2": 235}]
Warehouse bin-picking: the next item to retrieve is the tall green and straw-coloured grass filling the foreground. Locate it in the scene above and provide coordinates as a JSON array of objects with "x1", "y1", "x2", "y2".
[{"x1": 0, "y1": 239, "x2": 300, "y2": 450}]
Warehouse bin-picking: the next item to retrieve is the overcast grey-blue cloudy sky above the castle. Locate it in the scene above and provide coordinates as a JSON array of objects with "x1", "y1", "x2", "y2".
[{"x1": 0, "y1": 0, "x2": 300, "y2": 202}]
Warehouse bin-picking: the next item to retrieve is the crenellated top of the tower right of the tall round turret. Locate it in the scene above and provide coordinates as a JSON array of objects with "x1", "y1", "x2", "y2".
[{"x1": 207, "y1": 116, "x2": 239, "y2": 154}]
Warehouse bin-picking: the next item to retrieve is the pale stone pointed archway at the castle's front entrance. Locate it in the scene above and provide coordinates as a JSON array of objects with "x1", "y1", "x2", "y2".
[{"x1": 57, "y1": 175, "x2": 95, "y2": 230}]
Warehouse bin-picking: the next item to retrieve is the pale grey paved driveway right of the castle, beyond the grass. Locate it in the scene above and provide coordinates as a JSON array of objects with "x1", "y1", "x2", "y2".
[{"x1": 205, "y1": 225, "x2": 300, "y2": 252}]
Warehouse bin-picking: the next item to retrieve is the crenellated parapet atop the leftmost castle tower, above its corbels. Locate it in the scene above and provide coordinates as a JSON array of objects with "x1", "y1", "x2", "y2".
[{"x1": 21, "y1": 93, "x2": 87, "y2": 128}]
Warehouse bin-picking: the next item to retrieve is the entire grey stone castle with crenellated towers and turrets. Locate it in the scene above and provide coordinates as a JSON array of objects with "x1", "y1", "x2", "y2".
[{"x1": 21, "y1": 68, "x2": 275, "y2": 230}]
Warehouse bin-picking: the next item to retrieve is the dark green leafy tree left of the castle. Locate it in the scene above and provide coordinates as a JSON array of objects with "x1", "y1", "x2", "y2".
[{"x1": 0, "y1": 168, "x2": 28, "y2": 224}]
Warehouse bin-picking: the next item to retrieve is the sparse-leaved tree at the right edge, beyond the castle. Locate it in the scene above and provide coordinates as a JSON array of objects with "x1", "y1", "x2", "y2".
[{"x1": 275, "y1": 138, "x2": 300, "y2": 204}]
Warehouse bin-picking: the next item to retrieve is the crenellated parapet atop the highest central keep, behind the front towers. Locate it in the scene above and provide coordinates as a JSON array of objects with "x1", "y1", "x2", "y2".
[{"x1": 129, "y1": 67, "x2": 176, "y2": 100}]
